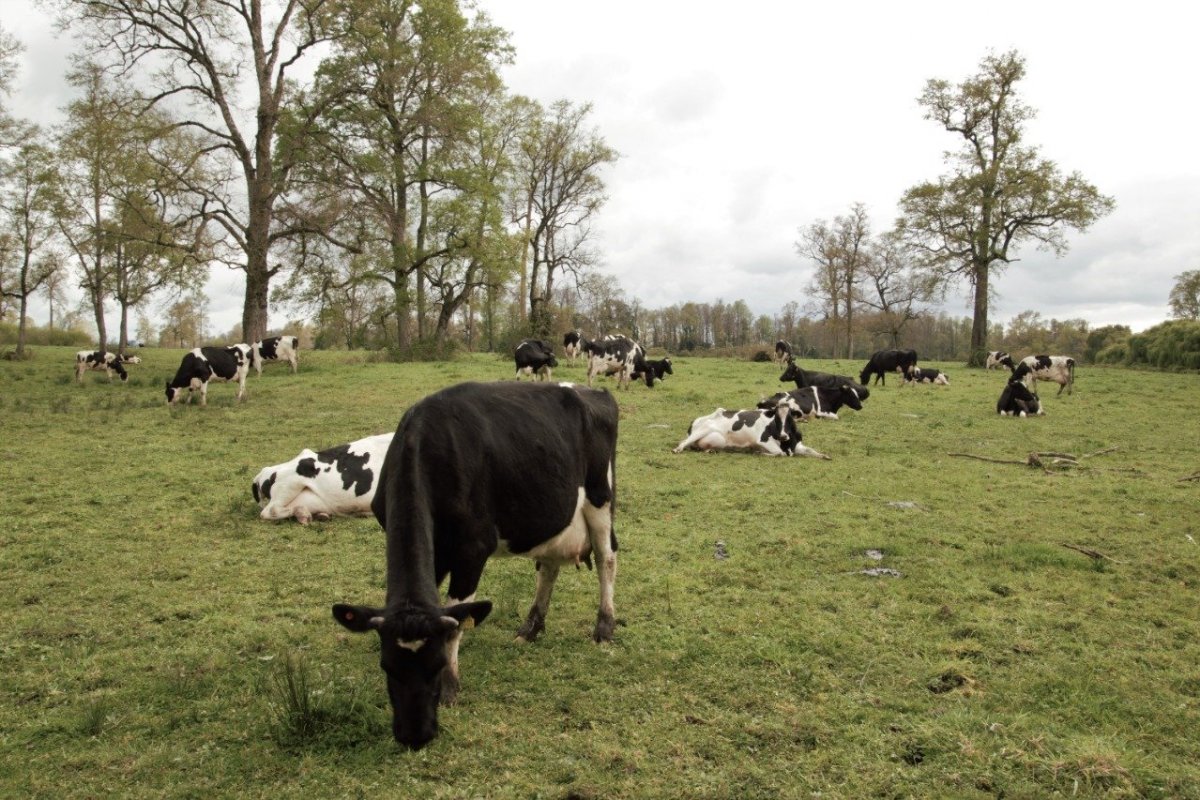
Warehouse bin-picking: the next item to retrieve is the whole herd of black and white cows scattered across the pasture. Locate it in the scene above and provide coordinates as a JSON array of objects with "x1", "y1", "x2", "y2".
[{"x1": 68, "y1": 331, "x2": 1075, "y2": 750}]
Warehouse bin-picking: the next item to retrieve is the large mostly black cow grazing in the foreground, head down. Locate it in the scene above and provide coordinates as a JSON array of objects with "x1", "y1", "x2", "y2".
[{"x1": 334, "y1": 381, "x2": 618, "y2": 750}]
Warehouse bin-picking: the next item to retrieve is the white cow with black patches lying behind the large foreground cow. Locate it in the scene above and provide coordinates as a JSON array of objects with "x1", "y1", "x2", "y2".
[{"x1": 251, "y1": 433, "x2": 394, "y2": 525}]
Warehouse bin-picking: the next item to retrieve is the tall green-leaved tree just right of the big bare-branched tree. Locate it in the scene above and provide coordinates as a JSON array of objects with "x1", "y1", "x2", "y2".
[{"x1": 302, "y1": 0, "x2": 510, "y2": 350}]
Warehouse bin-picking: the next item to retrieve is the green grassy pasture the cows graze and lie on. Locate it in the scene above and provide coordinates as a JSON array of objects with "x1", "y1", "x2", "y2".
[{"x1": 0, "y1": 348, "x2": 1200, "y2": 799}]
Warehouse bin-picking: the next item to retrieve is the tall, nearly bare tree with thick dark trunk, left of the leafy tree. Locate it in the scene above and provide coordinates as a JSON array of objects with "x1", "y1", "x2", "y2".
[{"x1": 67, "y1": 0, "x2": 331, "y2": 341}]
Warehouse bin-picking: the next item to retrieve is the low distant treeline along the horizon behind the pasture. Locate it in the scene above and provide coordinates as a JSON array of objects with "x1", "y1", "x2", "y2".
[{"x1": 9, "y1": 300, "x2": 1200, "y2": 369}]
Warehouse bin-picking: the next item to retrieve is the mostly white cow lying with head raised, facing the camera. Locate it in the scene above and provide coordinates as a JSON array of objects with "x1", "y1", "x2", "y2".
[{"x1": 672, "y1": 392, "x2": 829, "y2": 459}]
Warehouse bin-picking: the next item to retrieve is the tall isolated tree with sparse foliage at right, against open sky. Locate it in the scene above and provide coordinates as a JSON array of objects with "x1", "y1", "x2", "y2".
[{"x1": 898, "y1": 52, "x2": 1114, "y2": 366}]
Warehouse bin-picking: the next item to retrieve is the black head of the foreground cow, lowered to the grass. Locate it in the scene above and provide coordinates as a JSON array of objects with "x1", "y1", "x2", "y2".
[{"x1": 334, "y1": 600, "x2": 492, "y2": 750}]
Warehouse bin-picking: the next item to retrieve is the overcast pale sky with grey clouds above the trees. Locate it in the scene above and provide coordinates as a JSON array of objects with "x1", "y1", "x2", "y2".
[{"x1": 0, "y1": 0, "x2": 1200, "y2": 331}]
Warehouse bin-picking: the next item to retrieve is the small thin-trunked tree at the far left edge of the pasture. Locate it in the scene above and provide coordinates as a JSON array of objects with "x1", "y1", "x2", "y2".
[{"x1": 0, "y1": 134, "x2": 62, "y2": 357}]
